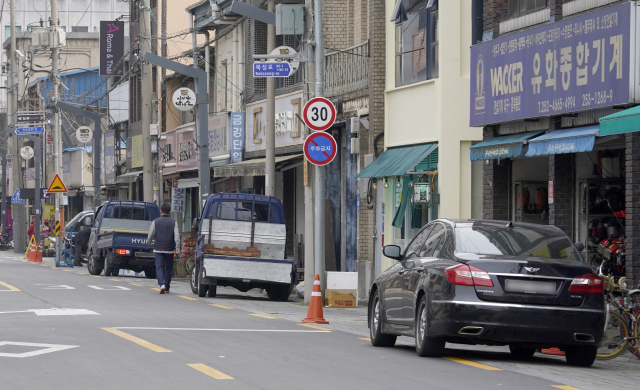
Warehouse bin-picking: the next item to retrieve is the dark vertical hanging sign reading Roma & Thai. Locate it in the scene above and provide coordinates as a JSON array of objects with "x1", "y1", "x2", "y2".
[{"x1": 100, "y1": 20, "x2": 124, "y2": 76}]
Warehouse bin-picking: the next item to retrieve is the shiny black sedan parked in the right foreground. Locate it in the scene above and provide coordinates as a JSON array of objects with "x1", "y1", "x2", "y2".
[{"x1": 369, "y1": 219, "x2": 606, "y2": 367}]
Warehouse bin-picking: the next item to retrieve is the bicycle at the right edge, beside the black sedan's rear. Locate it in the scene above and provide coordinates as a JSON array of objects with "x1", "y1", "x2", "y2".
[{"x1": 596, "y1": 275, "x2": 640, "y2": 360}]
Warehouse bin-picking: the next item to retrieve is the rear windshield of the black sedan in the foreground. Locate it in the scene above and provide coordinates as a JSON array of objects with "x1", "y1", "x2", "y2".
[{"x1": 456, "y1": 222, "x2": 582, "y2": 261}]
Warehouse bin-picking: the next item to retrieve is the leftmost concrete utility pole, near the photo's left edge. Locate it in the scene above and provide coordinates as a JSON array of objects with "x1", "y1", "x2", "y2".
[{"x1": 9, "y1": 0, "x2": 25, "y2": 253}]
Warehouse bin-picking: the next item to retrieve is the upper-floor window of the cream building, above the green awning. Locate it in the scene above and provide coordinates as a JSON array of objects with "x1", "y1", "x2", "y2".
[{"x1": 395, "y1": 0, "x2": 439, "y2": 87}]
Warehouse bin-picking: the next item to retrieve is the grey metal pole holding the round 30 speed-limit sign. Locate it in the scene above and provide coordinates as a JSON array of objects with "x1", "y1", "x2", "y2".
[{"x1": 313, "y1": 0, "x2": 325, "y2": 294}]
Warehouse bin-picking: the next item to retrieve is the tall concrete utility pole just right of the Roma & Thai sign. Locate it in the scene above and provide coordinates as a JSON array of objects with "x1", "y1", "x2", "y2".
[{"x1": 140, "y1": 0, "x2": 155, "y2": 202}]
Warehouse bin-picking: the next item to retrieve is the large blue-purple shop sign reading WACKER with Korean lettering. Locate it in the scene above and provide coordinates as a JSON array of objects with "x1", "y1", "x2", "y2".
[{"x1": 470, "y1": 3, "x2": 632, "y2": 126}]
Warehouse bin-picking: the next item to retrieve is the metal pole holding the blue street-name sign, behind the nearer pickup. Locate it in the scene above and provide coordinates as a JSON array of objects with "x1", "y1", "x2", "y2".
[{"x1": 264, "y1": 0, "x2": 276, "y2": 196}]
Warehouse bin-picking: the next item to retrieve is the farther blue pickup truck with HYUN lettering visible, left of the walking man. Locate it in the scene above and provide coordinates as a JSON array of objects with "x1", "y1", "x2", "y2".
[{"x1": 87, "y1": 200, "x2": 160, "y2": 278}]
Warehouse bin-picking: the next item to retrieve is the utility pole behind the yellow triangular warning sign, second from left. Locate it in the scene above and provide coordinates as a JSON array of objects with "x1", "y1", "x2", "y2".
[{"x1": 49, "y1": 0, "x2": 62, "y2": 233}]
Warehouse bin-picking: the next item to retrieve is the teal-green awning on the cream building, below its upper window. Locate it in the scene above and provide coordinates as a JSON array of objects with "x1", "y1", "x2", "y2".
[{"x1": 356, "y1": 142, "x2": 438, "y2": 179}]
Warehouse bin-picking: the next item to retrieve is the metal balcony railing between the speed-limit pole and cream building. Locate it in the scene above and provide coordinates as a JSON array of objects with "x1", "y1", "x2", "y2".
[{"x1": 324, "y1": 41, "x2": 369, "y2": 97}]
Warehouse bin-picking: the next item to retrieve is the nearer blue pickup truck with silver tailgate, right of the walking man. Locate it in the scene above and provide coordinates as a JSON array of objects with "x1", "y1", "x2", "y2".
[{"x1": 191, "y1": 193, "x2": 297, "y2": 301}]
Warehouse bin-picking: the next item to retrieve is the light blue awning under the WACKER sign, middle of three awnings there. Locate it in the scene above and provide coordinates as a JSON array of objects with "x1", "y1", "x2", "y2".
[{"x1": 525, "y1": 126, "x2": 600, "y2": 157}]
